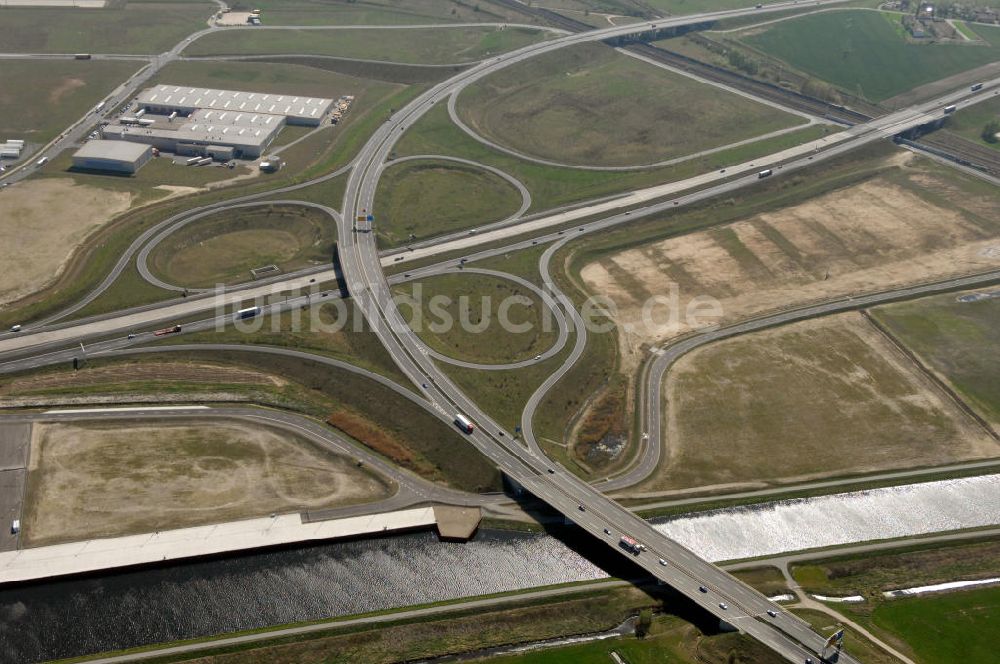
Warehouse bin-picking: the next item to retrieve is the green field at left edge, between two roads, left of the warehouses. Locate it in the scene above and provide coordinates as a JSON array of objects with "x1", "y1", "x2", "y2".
[{"x1": 0, "y1": 60, "x2": 142, "y2": 144}]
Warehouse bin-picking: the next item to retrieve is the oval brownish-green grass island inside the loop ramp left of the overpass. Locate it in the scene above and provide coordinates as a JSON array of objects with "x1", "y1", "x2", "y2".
[{"x1": 149, "y1": 205, "x2": 336, "y2": 288}]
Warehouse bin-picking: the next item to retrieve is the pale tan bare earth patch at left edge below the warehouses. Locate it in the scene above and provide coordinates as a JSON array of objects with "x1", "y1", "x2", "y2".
[{"x1": 0, "y1": 178, "x2": 132, "y2": 306}]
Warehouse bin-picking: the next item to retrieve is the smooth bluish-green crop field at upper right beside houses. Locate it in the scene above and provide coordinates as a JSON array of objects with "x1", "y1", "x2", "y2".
[{"x1": 743, "y1": 10, "x2": 1000, "y2": 102}]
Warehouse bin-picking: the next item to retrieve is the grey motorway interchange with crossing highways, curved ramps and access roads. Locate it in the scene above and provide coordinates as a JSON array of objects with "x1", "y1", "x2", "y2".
[{"x1": 0, "y1": 0, "x2": 1000, "y2": 663}]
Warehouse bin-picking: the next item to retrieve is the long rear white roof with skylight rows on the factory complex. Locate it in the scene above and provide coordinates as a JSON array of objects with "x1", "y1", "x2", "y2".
[{"x1": 137, "y1": 85, "x2": 333, "y2": 120}]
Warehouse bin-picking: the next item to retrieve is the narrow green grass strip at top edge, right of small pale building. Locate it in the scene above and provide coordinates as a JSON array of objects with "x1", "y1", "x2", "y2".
[{"x1": 233, "y1": 0, "x2": 529, "y2": 25}]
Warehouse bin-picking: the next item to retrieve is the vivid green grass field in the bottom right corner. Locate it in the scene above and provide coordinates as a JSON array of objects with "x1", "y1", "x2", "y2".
[{"x1": 872, "y1": 587, "x2": 1000, "y2": 664}]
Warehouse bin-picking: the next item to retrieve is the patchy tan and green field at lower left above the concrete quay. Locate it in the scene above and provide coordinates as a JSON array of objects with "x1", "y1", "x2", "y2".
[{"x1": 23, "y1": 420, "x2": 391, "y2": 546}]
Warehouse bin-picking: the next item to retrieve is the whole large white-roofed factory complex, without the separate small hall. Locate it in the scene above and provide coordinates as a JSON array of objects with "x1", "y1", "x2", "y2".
[{"x1": 101, "y1": 85, "x2": 334, "y2": 161}]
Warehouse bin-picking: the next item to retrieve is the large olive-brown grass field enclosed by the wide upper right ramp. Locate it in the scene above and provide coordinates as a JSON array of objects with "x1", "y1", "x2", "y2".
[{"x1": 458, "y1": 44, "x2": 805, "y2": 166}]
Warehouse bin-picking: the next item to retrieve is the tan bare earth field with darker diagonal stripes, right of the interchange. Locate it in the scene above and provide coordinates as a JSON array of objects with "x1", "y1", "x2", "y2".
[{"x1": 581, "y1": 155, "x2": 1000, "y2": 368}]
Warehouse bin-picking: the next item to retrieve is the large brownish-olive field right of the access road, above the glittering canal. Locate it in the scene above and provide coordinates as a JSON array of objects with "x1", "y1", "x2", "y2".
[{"x1": 647, "y1": 313, "x2": 1000, "y2": 489}]
